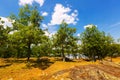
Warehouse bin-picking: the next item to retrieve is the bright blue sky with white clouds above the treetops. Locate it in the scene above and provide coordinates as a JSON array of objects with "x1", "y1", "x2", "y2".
[{"x1": 0, "y1": 0, "x2": 120, "y2": 39}]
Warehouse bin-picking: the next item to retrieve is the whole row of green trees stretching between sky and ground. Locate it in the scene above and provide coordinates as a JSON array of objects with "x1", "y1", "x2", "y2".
[{"x1": 0, "y1": 5, "x2": 120, "y2": 61}]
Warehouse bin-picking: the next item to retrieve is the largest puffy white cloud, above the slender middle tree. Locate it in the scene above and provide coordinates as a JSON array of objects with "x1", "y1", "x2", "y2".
[{"x1": 49, "y1": 4, "x2": 78, "y2": 25}]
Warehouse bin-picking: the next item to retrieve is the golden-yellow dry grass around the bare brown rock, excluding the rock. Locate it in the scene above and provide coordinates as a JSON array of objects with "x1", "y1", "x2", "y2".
[{"x1": 0, "y1": 57, "x2": 120, "y2": 80}]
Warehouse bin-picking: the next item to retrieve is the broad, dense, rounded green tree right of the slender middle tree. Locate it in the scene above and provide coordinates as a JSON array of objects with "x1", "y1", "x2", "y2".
[{"x1": 81, "y1": 25, "x2": 113, "y2": 61}]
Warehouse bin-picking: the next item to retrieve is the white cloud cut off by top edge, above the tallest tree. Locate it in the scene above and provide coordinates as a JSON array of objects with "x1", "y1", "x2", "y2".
[{"x1": 19, "y1": 0, "x2": 45, "y2": 7}]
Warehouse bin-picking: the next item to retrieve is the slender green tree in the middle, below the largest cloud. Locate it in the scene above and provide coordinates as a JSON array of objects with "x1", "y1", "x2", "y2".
[{"x1": 54, "y1": 21, "x2": 76, "y2": 61}]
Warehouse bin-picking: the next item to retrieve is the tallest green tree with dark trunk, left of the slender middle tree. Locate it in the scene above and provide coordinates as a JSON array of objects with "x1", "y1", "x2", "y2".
[{"x1": 10, "y1": 5, "x2": 45, "y2": 61}]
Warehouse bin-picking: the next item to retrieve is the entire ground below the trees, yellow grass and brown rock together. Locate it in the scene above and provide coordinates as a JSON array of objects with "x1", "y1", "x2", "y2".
[{"x1": 0, "y1": 57, "x2": 120, "y2": 80}]
